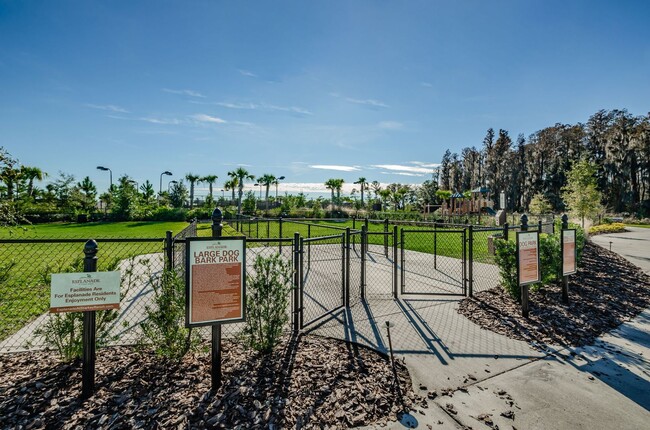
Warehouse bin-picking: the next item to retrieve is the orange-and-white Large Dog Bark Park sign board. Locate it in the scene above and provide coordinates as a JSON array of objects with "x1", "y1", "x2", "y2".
[{"x1": 185, "y1": 237, "x2": 246, "y2": 327}]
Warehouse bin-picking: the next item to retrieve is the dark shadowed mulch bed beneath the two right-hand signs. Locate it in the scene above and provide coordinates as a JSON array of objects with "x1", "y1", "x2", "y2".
[{"x1": 458, "y1": 242, "x2": 650, "y2": 346}]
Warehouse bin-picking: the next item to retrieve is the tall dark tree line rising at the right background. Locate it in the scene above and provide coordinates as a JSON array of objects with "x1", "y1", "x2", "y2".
[{"x1": 434, "y1": 109, "x2": 650, "y2": 217}]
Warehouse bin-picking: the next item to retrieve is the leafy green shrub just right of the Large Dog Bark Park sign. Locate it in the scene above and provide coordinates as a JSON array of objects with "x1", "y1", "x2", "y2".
[{"x1": 242, "y1": 254, "x2": 293, "y2": 352}]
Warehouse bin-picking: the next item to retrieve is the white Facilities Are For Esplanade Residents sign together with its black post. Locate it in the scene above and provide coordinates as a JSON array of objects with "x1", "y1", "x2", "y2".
[{"x1": 50, "y1": 240, "x2": 120, "y2": 399}]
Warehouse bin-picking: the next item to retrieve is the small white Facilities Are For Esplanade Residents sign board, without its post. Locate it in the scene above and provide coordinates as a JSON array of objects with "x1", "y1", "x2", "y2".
[{"x1": 50, "y1": 271, "x2": 120, "y2": 313}]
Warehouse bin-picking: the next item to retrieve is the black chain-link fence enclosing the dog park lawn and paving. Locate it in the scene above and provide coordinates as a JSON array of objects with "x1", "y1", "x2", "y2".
[{"x1": 0, "y1": 214, "x2": 554, "y2": 353}]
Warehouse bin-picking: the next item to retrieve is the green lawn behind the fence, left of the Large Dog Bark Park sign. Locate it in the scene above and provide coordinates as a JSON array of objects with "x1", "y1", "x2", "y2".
[{"x1": 0, "y1": 222, "x2": 188, "y2": 339}]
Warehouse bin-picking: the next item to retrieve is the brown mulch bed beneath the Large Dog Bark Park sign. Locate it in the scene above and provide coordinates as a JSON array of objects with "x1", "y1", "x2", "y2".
[{"x1": 0, "y1": 336, "x2": 421, "y2": 429}]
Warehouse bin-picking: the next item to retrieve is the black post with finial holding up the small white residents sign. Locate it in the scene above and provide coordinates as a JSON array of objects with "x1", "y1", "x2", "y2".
[{"x1": 81, "y1": 240, "x2": 98, "y2": 399}]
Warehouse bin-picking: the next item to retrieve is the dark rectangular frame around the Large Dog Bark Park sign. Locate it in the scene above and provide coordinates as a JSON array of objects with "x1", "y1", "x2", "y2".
[{"x1": 185, "y1": 236, "x2": 246, "y2": 328}]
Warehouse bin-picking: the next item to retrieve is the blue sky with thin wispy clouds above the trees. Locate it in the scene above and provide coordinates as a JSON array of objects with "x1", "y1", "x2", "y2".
[{"x1": 0, "y1": 0, "x2": 650, "y2": 195}]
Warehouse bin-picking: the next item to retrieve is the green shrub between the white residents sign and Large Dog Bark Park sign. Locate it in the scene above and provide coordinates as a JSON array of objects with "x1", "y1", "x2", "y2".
[{"x1": 140, "y1": 270, "x2": 200, "y2": 360}]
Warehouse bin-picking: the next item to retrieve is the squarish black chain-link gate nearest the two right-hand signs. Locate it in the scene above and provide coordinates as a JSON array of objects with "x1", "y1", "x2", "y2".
[{"x1": 399, "y1": 226, "x2": 467, "y2": 296}]
